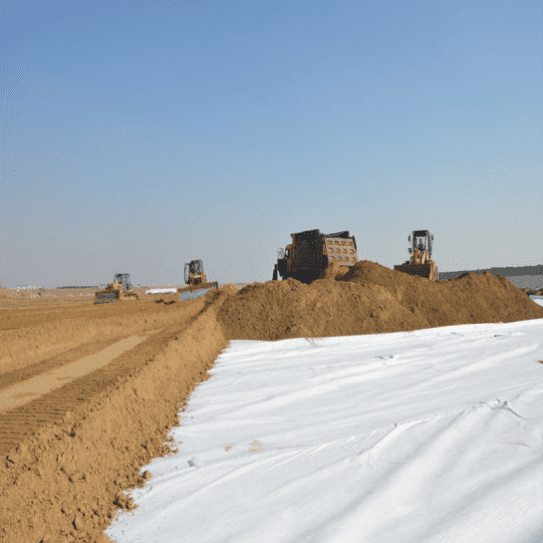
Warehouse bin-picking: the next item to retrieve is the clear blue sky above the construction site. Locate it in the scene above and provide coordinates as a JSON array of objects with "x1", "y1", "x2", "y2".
[{"x1": 0, "y1": 0, "x2": 543, "y2": 287}]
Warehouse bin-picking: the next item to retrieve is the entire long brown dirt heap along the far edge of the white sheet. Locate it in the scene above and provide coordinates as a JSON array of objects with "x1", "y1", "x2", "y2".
[{"x1": 218, "y1": 260, "x2": 543, "y2": 341}]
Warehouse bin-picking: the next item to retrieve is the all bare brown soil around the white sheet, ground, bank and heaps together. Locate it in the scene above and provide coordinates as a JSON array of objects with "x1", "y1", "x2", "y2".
[{"x1": 0, "y1": 272, "x2": 543, "y2": 543}]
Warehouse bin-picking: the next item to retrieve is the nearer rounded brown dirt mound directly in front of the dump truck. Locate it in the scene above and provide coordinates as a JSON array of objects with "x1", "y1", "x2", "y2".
[{"x1": 218, "y1": 279, "x2": 425, "y2": 341}]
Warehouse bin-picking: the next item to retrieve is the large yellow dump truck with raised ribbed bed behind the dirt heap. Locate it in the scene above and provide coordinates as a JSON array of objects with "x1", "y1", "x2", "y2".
[{"x1": 272, "y1": 230, "x2": 358, "y2": 284}]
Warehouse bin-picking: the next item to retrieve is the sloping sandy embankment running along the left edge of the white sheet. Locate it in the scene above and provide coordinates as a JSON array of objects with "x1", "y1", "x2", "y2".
[{"x1": 0, "y1": 286, "x2": 232, "y2": 542}]
